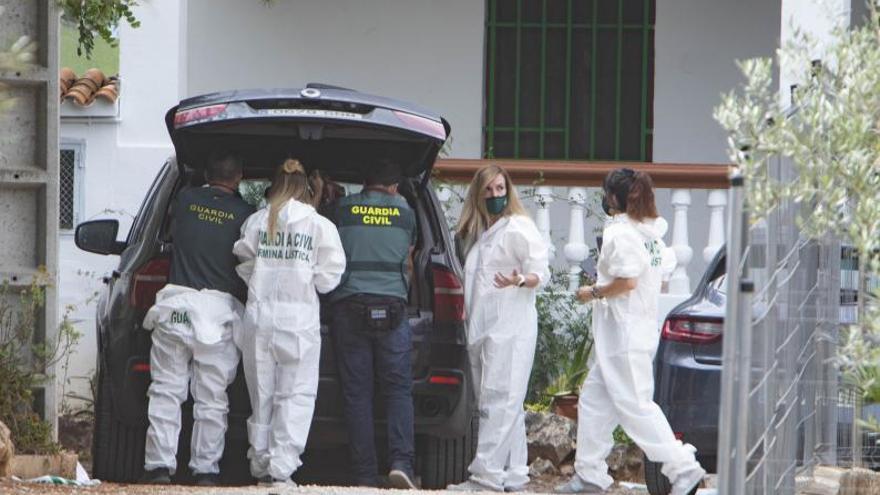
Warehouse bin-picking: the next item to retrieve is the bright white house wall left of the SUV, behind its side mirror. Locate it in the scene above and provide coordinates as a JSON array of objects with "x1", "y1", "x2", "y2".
[{"x1": 59, "y1": 0, "x2": 185, "y2": 408}]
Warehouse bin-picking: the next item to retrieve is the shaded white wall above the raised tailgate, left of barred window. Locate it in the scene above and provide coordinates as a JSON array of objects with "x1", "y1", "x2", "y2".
[{"x1": 186, "y1": 0, "x2": 485, "y2": 158}]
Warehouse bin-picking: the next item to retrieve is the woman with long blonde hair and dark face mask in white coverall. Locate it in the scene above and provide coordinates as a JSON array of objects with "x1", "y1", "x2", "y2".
[{"x1": 448, "y1": 165, "x2": 550, "y2": 491}]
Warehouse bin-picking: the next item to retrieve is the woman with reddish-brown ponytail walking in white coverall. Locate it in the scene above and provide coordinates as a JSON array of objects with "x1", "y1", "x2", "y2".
[{"x1": 556, "y1": 169, "x2": 706, "y2": 495}]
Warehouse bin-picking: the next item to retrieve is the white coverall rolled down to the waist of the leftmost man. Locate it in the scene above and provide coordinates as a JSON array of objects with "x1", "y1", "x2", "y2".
[{"x1": 143, "y1": 284, "x2": 244, "y2": 474}]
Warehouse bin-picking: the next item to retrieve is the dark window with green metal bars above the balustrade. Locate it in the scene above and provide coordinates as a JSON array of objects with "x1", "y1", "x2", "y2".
[{"x1": 483, "y1": 0, "x2": 656, "y2": 161}]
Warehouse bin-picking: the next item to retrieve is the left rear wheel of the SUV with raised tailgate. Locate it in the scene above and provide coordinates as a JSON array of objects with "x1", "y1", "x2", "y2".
[{"x1": 92, "y1": 366, "x2": 146, "y2": 482}]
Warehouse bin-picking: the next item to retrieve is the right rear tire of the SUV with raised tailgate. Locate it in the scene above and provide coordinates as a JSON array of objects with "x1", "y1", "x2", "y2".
[{"x1": 419, "y1": 415, "x2": 479, "y2": 490}]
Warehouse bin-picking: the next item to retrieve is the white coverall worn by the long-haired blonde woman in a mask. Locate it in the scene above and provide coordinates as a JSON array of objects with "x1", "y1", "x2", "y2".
[{"x1": 465, "y1": 215, "x2": 550, "y2": 490}]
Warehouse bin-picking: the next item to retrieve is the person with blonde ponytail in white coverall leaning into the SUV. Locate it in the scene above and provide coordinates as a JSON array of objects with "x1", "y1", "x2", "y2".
[{"x1": 233, "y1": 159, "x2": 345, "y2": 485}]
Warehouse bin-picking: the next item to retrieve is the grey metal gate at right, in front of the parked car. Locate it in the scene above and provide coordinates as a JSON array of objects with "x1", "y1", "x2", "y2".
[{"x1": 718, "y1": 158, "x2": 841, "y2": 495}]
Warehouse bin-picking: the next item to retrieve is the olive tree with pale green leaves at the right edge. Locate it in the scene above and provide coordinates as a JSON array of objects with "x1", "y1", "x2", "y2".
[{"x1": 715, "y1": 5, "x2": 880, "y2": 438}]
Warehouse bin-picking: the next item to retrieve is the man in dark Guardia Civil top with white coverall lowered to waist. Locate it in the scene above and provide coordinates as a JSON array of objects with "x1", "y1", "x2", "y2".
[{"x1": 143, "y1": 152, "x2": 254, "y2": 485}]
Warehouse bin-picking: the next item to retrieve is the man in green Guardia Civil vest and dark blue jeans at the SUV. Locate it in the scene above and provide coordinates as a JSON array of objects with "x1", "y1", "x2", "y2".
[{"x1": 330, "y1": 161, "x2": 416, "y2": 488}]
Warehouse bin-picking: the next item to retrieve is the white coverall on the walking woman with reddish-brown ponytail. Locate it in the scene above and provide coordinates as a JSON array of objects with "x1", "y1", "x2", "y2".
[{"x1": 575, "y1": 214, "x2": 699, "y2": 489}]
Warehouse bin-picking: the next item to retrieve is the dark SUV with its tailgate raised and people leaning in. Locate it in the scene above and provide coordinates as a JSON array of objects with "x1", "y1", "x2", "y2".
[{"x1": 76, "y1": 84, "x2": 476, "y2": 488}]
